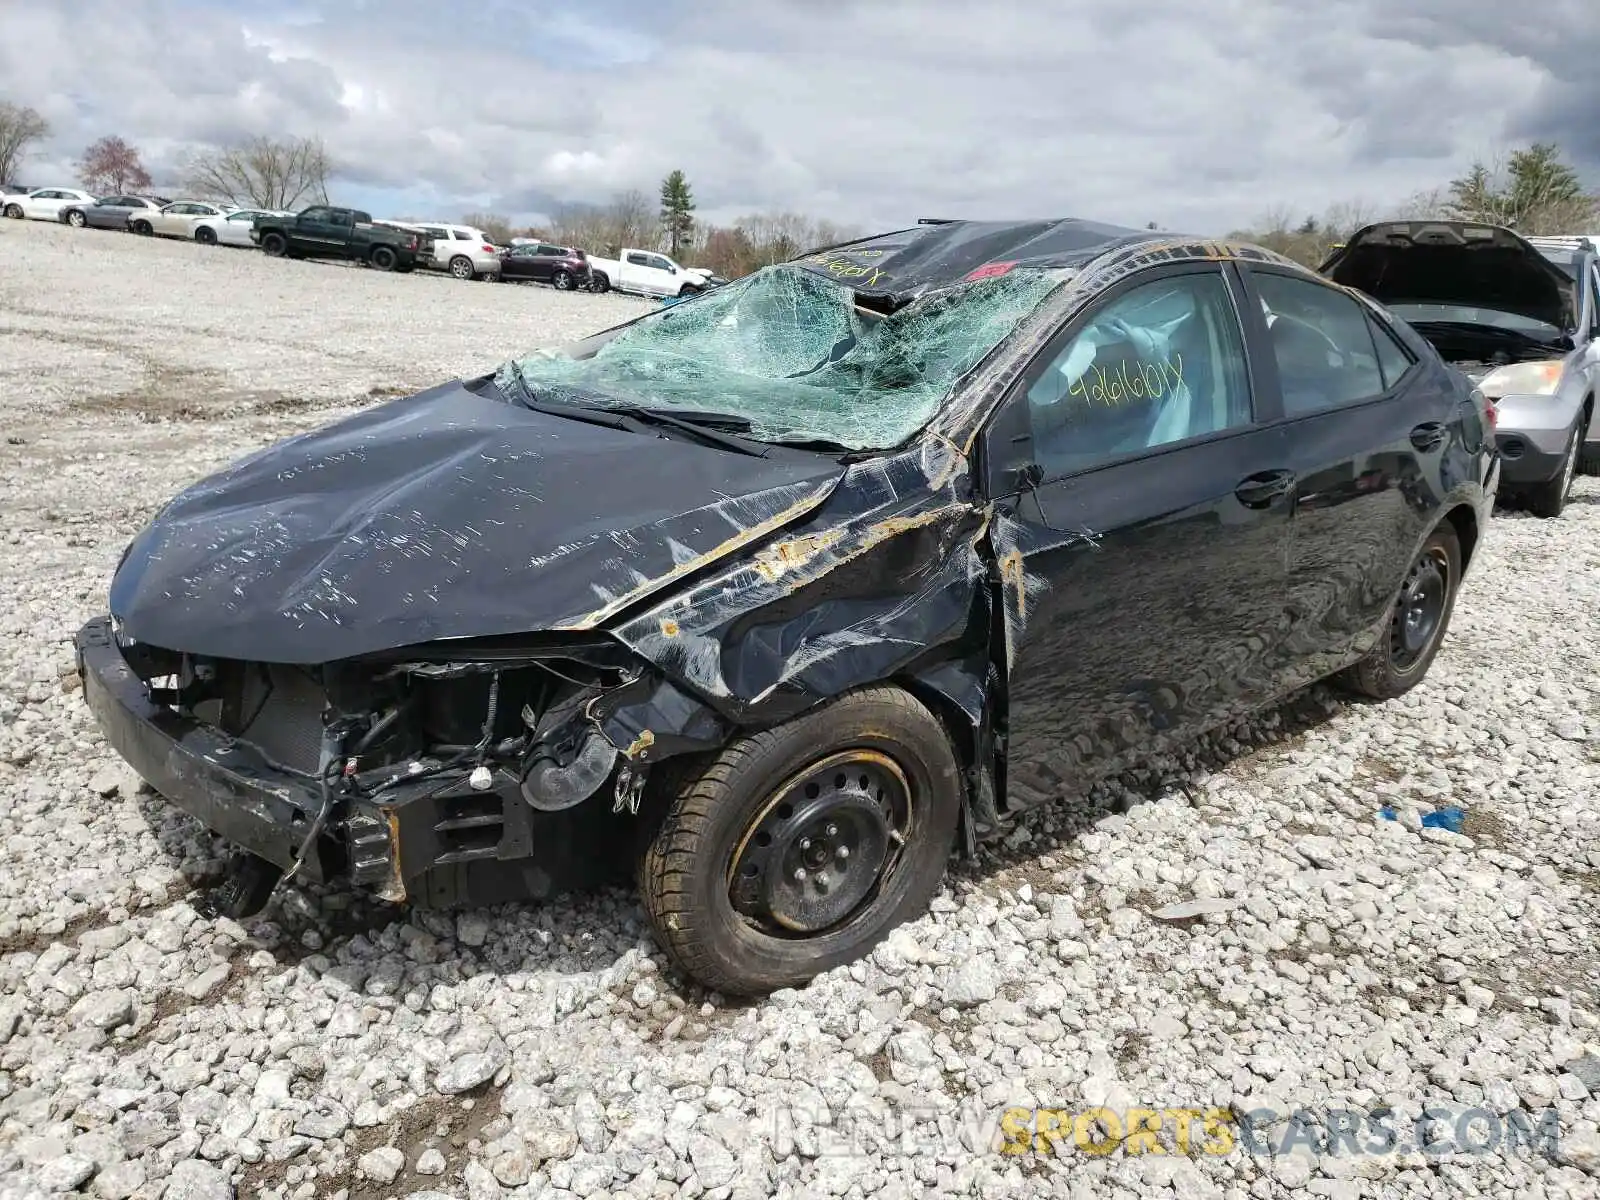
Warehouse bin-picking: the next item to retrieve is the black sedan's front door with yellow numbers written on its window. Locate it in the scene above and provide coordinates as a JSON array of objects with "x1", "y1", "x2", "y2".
[{"x1": 984, "y1": 262, "x2": 1293, "y2": 806}]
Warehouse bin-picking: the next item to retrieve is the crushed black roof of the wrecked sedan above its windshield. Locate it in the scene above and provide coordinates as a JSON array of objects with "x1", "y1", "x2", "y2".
[{"x1": 790, "y1": 218, "x2": 1310, "y2": 298}]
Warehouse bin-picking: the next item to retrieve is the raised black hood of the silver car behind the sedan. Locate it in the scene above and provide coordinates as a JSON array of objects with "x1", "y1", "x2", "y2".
[{"x1": 1322, "y1": 221, "x2": 1578, "y2": 330}]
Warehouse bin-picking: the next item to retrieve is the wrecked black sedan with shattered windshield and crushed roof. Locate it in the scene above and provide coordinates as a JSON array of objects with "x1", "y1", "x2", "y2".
[{"x1": 78, "y1": 221, "x2": 1498, "y2": 994}]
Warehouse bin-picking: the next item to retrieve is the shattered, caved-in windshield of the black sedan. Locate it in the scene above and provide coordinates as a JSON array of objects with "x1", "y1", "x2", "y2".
[{"x1": 499, "y1": 266, "x2": 1061, "y2": 450}]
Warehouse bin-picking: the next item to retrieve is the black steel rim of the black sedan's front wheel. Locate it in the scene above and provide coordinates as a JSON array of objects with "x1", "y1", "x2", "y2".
[{"x1": 726, "y1": 749, "x2": 914, "y2": 938}]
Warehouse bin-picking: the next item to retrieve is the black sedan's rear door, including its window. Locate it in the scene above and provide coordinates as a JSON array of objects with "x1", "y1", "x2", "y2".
[{"x1": 1243, "y1": 264, "x2": 1478, "y2": 685}]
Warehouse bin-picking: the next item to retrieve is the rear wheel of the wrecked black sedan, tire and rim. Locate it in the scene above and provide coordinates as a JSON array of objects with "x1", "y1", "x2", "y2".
[{"x1": 1339, "y1": 520, "x2": 1461, "y2": 699}]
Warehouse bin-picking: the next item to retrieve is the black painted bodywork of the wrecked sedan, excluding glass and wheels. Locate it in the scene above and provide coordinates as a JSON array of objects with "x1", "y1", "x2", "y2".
[{"x1": 80, "y1": 222, "x2": 1498, "y2": 902}]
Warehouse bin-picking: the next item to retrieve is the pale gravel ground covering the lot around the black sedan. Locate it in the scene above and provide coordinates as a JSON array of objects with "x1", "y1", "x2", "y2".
[{"x1": 0, "y1": 222, "x2": 1600, "y2": 1200}]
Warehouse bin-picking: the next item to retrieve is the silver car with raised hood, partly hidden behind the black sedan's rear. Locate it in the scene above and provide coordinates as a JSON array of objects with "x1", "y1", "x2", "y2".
[{"x1": 1322, "y1": 221, "x2": 1600, "y2": 517}]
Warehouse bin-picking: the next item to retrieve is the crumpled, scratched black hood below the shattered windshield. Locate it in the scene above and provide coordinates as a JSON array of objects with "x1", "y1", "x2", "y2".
[{"x1": 110, "y1": 382, "x2": 843, "y2": 664}]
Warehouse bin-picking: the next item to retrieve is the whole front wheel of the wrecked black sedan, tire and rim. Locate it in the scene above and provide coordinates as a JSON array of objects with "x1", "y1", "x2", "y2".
[{"x1": 638, "y1": 686, "x2": 963, "y2": 995}]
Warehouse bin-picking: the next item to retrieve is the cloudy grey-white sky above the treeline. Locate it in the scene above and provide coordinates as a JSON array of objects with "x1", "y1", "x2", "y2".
[{"x1": 0, "y1": 0, "x2": 1600, "y2": 234}]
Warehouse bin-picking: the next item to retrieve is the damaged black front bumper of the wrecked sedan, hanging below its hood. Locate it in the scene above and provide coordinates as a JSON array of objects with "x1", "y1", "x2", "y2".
[{"x1": 77, "y1": 618, "x2": 649, "y2": 907}]
